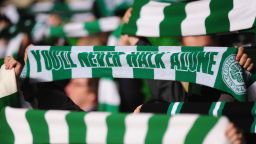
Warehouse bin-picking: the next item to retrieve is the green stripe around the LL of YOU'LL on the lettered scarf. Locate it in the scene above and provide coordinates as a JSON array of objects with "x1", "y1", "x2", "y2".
[{"x1": 50, "y1": 46, "x2": 72, "y2": 80}]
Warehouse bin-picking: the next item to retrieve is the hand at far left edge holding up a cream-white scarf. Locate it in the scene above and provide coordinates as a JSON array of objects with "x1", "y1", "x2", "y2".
[{"x1": 4, "y1": 56, "x2": 22, "y2": 77}]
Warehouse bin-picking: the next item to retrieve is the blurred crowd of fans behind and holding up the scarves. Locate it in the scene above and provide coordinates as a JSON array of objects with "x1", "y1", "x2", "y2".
[{"x1": 0, "y1": 0, "x2": 256, "y2": 143}]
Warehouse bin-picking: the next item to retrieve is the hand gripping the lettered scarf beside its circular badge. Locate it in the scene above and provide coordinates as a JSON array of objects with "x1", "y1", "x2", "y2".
[{"x1": 236, "y1": 47, "x2": 253, "y2": 71}]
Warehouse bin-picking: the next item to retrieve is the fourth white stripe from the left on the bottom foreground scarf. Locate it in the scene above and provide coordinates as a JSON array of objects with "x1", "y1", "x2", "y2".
[{"x1": 124, "y1": 114, "x2": 152, "y2": 144}]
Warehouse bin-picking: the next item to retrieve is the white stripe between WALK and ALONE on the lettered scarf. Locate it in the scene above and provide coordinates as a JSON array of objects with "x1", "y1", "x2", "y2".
[{"x1": 152, "y1": 46, "x2": 181, "y2": 80}]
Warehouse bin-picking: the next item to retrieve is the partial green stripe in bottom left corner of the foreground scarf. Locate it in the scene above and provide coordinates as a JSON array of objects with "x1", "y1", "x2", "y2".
[{"x1": 0, "y1": 108, "x2": 14, "y2": 144}]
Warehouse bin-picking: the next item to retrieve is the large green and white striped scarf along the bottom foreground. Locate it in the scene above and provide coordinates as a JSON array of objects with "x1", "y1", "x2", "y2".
[{"x1": 0, "y1": 107, "x2": 229, "y2": 144}]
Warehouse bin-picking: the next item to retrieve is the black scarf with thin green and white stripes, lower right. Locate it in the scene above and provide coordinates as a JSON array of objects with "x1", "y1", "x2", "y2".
[{"x1": 141, "y1": 102, "x2": 256, "y2": 134}]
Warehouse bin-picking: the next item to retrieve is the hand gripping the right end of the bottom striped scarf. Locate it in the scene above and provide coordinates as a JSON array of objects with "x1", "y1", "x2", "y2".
[{"x1": 226, "y1": 123, "x2": 243, "y2": 144}]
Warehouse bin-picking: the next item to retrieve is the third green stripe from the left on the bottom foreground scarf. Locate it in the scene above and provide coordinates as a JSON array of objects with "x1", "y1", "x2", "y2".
[{"x1": 66, "y1": 112, "x2": 86, "y2": 143}]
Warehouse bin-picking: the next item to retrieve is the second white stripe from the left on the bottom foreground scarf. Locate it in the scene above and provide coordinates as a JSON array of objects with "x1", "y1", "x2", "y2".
[{"x1": 45, "y1": 110, "x2": 69, "y2": 143}]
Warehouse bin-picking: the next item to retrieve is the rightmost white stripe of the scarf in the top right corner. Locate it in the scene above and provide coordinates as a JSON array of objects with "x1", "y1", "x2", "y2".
[{"x1": 228, "y1": 0, "x2": 256, "y2": 31}]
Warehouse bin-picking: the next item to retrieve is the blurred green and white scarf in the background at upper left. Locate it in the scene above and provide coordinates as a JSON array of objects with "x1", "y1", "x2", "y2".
[{"x1": 47, "y1": 17, "x2": 120, "y2": 37}]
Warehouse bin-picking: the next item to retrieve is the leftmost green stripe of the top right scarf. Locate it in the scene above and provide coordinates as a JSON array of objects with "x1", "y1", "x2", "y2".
[{"x1": 123, "y1": 0, "x2": 150, "y2": 35}]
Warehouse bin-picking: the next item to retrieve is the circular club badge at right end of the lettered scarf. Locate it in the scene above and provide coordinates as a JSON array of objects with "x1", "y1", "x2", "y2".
[{"x1": 222, "y1": 55, "x2": 246, "y2": 95}]
